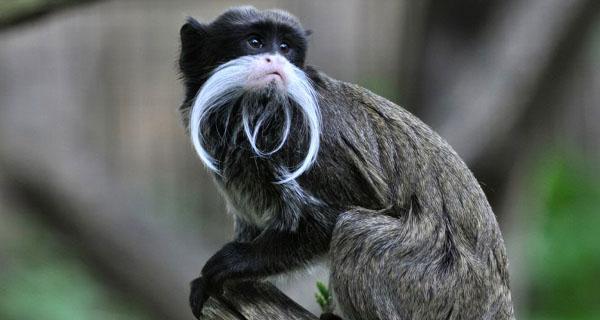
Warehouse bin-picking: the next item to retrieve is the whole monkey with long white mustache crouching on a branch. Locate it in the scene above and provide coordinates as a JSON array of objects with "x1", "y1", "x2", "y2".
[{"x1": 179, "y1": 7, "x2": 514, "y2": 320}]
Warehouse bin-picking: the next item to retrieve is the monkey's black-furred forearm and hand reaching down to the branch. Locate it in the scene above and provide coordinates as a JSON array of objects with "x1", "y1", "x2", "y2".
[{"x1": 190, "y1": 219, "x2": 331, "y2": 316}]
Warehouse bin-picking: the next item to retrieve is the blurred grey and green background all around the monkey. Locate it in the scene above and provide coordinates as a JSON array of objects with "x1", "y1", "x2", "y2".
[{"x1": 0, "y1": 0, "x2": 600, "y2": 320}]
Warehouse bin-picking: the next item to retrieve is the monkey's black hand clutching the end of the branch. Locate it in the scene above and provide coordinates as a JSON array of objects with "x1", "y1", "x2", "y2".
[{"x1": 190, "y1": 242, "x2": 256, "y2": 319}]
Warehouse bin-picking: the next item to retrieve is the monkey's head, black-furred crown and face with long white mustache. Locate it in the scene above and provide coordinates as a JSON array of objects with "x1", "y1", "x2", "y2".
[{"x1": 179, "y1": 7, "x2": 320, "y2": 182}]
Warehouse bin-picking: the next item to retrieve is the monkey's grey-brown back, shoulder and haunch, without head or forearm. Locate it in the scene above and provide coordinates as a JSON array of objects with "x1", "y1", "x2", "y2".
[{"x1": 301, "y1": 72, "x2": 514, "y2": 319}]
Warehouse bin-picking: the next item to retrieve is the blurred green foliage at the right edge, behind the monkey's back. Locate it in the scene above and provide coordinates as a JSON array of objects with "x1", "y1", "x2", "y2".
[{"x1": 523, "y1": 152, "x2": 600, "y2": 320}]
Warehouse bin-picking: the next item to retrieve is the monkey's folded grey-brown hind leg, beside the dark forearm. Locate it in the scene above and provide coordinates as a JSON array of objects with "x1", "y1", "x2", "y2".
[{"x1": 330, "y1": 209, "x2": 511, "y2": 320}]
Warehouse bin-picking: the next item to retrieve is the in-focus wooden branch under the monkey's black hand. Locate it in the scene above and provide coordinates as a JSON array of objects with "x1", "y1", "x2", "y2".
[{"x1": 201, "y1": 282, "x2": 318, "y2": 320}]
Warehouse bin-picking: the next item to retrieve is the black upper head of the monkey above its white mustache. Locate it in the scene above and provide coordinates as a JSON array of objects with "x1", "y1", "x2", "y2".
[{"x1": 179, "y1": 7, "x2": 308, "y2": 98}]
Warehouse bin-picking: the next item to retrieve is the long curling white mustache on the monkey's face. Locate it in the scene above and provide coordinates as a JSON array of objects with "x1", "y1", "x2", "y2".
[{"x1": 190, "y1": 55, "x2": 321, "y2": 184}]
